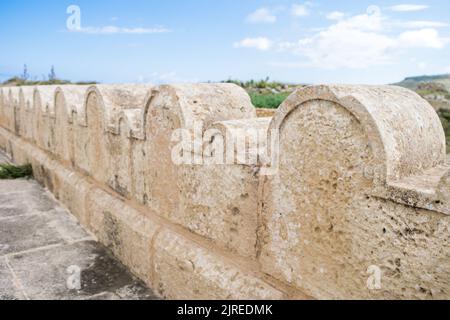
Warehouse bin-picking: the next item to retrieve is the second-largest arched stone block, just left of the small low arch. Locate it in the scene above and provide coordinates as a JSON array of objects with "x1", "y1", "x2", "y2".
[{"x1": 133, "y1": 84, "x2": 256, "y2": 229}]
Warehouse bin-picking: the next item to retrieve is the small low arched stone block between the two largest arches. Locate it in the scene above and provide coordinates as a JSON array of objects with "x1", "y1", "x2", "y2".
[{"x1": 171, "y1": 118, "x2": 270, "y2": 258}]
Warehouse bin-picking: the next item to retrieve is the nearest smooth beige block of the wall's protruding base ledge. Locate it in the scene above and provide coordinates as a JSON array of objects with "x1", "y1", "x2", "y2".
[{"x1": 154, "y1": 231, "x2": 283, "y2": 300}]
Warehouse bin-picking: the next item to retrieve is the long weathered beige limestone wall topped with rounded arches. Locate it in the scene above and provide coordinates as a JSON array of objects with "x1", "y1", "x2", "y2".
[{"x1": 0, "y1": 84, "x2": 450, "y2": 299}]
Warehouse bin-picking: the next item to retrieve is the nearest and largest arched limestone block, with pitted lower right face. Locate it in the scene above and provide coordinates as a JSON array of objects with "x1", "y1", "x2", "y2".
[{"x1": 259, "y1": 86, "x2": 450, "y2": 299}]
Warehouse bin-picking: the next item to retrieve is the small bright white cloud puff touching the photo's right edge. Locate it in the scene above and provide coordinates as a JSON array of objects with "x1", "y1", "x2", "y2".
[{"x1": 398, "y1": 28, "x2": 449, "y2": 49}]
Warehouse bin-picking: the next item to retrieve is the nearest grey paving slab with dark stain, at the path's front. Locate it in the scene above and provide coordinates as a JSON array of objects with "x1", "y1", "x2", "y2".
[{"x1": 8, "y1": 241, "x2": 154, "y2": 300}]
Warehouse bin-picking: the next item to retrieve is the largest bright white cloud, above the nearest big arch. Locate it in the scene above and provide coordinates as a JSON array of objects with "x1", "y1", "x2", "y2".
[{"x1": 277, "y1": 7, "x2": 450, "y2": 69}]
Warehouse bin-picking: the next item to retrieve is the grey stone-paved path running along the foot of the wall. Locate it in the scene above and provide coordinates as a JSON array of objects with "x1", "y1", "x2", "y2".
[{"x1": 0, "y1": 154, "x2": 155, "y2": 300}]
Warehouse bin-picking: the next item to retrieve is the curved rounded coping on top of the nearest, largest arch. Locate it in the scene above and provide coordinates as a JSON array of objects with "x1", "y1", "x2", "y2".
[{"x1": 269, "y1": 85, "x2": 446, "y2": 185}]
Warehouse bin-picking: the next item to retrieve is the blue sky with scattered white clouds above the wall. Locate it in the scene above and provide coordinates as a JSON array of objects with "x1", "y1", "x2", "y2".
[{"x1": 0, "y1": 0, "x2": 450, "y2": 84}]
